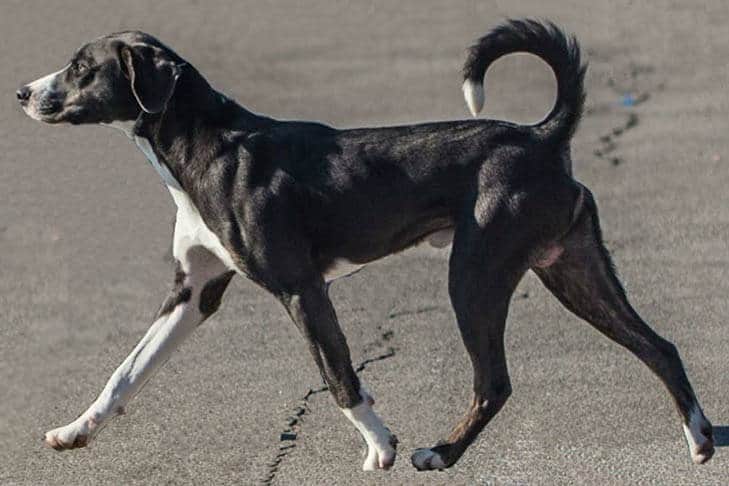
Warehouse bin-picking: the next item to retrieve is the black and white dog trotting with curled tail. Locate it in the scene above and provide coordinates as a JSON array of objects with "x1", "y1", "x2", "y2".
[{"x1": 17, "y1": 20, "x2": 714, "y2": 470}]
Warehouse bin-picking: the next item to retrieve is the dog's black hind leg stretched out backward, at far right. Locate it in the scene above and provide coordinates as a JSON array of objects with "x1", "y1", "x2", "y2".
[{"x1": 534, "y1": 190, "x2": 714, "y2": 464}]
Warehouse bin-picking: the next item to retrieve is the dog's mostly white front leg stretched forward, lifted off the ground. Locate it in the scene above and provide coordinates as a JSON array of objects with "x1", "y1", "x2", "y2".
[{"x1": 45, "y1": 246, "x2": 233, "y2": 450}]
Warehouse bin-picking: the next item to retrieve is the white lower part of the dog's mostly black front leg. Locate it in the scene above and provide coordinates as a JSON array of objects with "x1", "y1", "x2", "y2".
[{"x1": 342, "y1": 388, "x2": 396, "y2": 471}]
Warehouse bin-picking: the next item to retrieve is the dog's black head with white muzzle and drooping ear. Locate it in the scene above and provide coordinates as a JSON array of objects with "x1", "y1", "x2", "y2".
[{"x1": 16, "y1": 32, "x2": 185, "y2": 124}]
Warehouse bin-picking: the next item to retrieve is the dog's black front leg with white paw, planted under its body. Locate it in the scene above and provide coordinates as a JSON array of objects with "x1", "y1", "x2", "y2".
[{"x1": 282, "y1": 279, "x2": 397, "y2": 471}]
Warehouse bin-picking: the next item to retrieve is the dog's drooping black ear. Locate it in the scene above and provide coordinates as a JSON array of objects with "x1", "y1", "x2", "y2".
[{"x1": 119, "y1": 44, "x2": 181, "y2": 113}]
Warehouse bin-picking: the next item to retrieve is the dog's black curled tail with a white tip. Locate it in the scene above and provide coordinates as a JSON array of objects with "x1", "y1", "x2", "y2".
[{"x1": 463, "y1": 19, "x2": 587, "y2": 144}]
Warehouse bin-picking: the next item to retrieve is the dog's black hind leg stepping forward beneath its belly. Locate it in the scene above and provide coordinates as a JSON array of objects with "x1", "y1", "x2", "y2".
[{"x1": 411, "y1": 196, "x2": 530, "y2": 471}]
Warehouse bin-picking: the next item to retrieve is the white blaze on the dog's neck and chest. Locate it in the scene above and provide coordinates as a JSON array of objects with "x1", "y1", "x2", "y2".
[{"x1": 134, "y1": 136, "x2": 238, "y2": 271}]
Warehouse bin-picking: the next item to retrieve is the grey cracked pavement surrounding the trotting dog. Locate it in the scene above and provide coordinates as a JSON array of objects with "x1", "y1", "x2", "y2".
[{"x1": 0, "y1": 0, "x2": 729, "y2": 485}]
